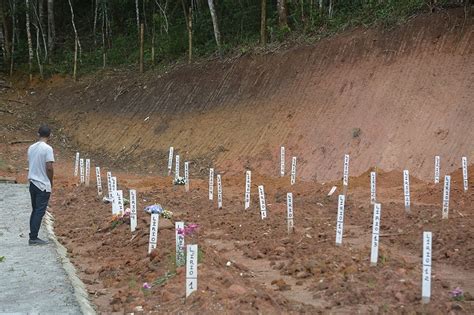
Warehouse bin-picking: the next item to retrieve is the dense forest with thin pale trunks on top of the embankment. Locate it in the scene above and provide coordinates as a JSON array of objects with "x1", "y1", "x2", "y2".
[{"x1": 0, "y1": 0, "x2": 471, "y2": 79}]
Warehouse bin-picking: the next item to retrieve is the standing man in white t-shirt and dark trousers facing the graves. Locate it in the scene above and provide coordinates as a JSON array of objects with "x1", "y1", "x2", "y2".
[{"x1": 28, "y1": 125, "x2": 54, "y2": 245}]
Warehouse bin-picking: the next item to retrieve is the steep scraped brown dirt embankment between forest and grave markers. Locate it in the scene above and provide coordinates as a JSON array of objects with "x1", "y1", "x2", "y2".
[{"x1": 40, "y1": 11, "x2": 474, "y2": 180}]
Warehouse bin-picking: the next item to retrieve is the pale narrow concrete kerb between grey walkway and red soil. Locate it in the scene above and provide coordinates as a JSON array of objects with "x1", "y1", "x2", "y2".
[{"x1": 44, "y1": 211, "x2": 97, "y2": 315}]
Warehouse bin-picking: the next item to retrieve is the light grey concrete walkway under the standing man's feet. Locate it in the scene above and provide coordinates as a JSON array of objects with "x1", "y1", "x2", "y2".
[{"x1": 0, "y1": 184, "x2": 83, "y2": 314}]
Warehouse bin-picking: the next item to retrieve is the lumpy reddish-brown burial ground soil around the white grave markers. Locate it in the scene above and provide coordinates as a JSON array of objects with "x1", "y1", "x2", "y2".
[{"x1": 52, "y1": 167, "x2": 474, "y2": 314}]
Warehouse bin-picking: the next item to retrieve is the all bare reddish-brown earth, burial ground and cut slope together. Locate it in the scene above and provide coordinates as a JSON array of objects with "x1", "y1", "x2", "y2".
[{"x1": 0, "y1": 11, "x2": 474, "y2": 314}]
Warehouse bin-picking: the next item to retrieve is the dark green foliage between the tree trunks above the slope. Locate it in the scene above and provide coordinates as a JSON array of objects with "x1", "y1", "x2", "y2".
[{"x1": 0, "y1": 0, "x2": 466, "y2": 76}]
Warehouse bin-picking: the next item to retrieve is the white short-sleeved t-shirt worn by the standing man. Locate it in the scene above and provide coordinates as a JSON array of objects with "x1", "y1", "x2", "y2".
[{"x1": 28, "y1": 141, "x2": 54, "y2": 192}]
